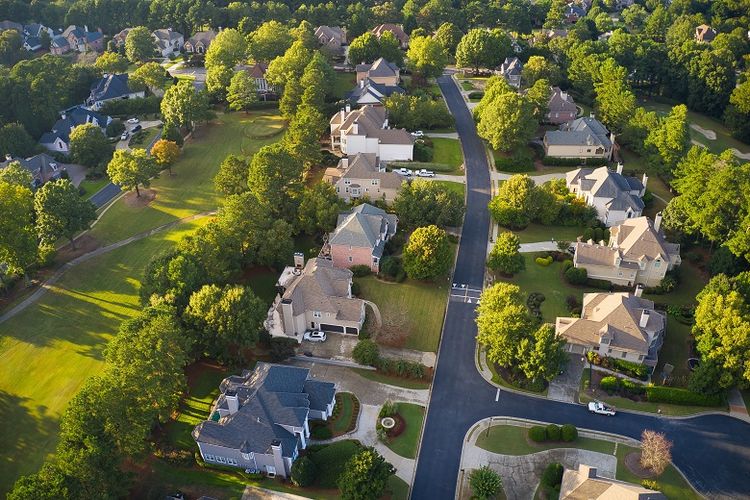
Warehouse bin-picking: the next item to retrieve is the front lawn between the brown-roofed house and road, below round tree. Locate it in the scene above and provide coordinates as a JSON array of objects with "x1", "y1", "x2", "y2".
[{"x1": 356, "y1": 276, "x2": 448, "y2": 352}]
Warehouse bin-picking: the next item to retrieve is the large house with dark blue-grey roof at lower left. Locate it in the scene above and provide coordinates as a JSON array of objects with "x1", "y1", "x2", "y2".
[{"x1": 193, "y1": 362, "x2": 336, "y2": 477}]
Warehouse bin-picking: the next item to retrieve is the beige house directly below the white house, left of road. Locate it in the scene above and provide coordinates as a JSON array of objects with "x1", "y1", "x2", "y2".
[{"x1": 323, "y1": 153, "x2": 404, "y2": 203}]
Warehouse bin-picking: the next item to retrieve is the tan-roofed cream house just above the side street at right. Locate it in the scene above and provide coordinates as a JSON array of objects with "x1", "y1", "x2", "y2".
[{"x1": 555, "y1": 292, "x2": 667, "y2": 368}]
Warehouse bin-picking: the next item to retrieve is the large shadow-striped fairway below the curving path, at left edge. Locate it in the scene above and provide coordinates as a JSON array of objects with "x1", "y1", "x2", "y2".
[{"x1": 0, "y1": 219, "x2": 206, "y2": 493}]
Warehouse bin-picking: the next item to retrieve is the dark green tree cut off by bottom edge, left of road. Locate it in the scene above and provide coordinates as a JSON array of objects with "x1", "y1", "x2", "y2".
[{"x1": 337, "y1": 447, "x2": 396, "y2": 500}]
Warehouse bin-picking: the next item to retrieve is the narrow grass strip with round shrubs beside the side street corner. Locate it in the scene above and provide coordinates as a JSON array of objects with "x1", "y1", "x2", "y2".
[{"x1": 476, "y1": 425, "x2": 615, "y2": 456}]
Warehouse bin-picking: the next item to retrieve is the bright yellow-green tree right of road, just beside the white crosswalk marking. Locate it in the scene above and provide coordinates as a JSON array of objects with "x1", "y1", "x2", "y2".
[{"x1": 476, "y1": 283, "x2": 534, "y2": 366}]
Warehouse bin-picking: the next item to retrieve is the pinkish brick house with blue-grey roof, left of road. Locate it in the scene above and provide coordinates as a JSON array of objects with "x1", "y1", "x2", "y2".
[{"x1": 323, "y1": 203, "x2": 398, "y2": 272}]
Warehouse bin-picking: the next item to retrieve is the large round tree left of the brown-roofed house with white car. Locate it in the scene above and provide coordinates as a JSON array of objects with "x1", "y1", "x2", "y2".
[{"x1": 183, "y1": 285, "x2": 266, "y2": 361}]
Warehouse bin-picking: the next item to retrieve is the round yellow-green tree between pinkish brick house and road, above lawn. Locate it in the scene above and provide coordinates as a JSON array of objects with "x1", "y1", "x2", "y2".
[{"x1": 403, "y1": 225, "x2": 453, "y2": 280}]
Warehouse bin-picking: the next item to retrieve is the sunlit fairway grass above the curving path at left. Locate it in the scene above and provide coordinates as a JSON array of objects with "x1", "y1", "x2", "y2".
[{"x1": 91, "y1": 110, "x2": 283, "y2": 243}]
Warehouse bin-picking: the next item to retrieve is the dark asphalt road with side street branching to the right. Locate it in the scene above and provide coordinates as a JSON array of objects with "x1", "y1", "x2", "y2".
[{"x1": 412, "y1": 77, "x2": 750, "y2": 500}]
